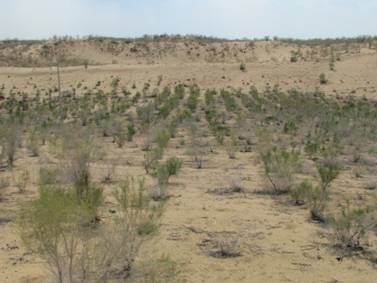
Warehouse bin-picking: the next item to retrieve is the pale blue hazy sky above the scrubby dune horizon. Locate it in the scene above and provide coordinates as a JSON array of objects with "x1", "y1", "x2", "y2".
[{"x1": 0, "y1": 0, "x2": 377, "y2": 39}]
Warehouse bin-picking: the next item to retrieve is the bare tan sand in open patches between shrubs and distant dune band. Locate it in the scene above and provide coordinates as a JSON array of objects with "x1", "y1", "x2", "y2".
[{"x1": 0, "y1": 39, "x2": 377, "y2": 283}]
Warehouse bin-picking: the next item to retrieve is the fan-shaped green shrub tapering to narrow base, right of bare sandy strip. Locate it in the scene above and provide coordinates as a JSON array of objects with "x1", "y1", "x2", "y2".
[{"x1": 261, "y1": 147, "x2": 300, "y2": 194}]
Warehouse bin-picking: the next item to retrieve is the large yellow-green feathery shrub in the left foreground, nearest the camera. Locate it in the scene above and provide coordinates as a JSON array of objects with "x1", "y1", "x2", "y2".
[{"x1": 18, "y1": 187, "x2": 94, "y2": 283}]
